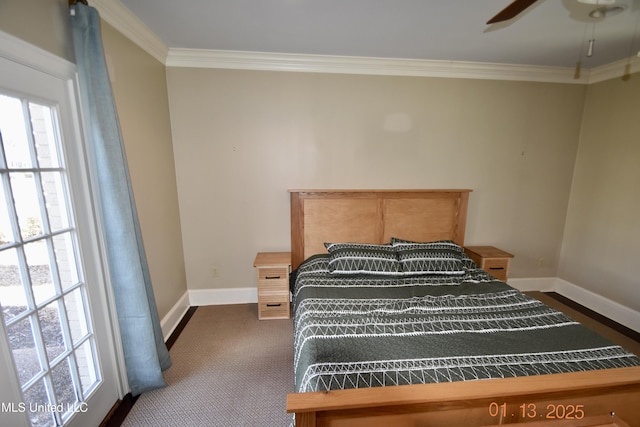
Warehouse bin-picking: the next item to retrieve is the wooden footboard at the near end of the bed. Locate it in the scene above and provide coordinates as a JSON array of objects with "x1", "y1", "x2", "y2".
[{"x1": 287, "y1": 367, "x2": 640, "y2": 427}]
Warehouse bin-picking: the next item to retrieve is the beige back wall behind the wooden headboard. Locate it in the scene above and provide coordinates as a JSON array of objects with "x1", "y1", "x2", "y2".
[{"x1": 167, "y1": 68, "x2": 585, "y2": 289}]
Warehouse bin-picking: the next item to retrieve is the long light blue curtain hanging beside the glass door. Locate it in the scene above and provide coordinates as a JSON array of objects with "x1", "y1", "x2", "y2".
[{"x1": 71, "y1": 3, "x2": 171, "y2": 396}]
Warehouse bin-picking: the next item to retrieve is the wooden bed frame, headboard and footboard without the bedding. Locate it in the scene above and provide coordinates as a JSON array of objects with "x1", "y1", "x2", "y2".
[{"x1": 287, "y1": 190, "x2": 640, "y2": 427}]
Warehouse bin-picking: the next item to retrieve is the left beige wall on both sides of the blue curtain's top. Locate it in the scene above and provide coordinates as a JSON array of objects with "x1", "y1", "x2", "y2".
[{"x1": 0, "y1": 0, "x2": 187, "y2": 318}]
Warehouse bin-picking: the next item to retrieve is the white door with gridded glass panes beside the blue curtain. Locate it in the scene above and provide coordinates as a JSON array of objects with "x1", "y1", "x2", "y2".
[{"x1": 0, "y1": 47, "x2": 119, "y2": 426}]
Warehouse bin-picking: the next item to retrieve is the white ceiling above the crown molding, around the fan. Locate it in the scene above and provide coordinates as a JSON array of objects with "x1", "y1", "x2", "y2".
[{"x1": 121, "y1": 0, "x2": 640, "y2": 69}]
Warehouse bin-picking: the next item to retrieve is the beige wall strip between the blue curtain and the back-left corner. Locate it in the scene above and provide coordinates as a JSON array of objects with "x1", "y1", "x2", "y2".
[{"x1": 102, "y1": 21, "x2": 187, "y2": 318}]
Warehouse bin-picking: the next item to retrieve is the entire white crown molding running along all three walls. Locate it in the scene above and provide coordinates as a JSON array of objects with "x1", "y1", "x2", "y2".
[{"x1": 91, "y1": 0, "x2": 640, "y2": 84}]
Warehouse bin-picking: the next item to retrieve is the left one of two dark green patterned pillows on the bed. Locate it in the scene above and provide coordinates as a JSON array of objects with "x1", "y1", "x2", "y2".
[{"x1": 324, "y1": 243, "x2": 400, "y2": 275}]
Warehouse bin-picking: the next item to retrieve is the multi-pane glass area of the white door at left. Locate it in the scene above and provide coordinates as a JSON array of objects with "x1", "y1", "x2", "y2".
[{"x1": 0, "y1": 95, "x2": 100, "y2": 426}]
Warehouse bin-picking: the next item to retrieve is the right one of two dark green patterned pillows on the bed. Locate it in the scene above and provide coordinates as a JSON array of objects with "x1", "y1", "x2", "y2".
[{"x1": 392, "y1": 239, "x2": 465, "y2": 276}]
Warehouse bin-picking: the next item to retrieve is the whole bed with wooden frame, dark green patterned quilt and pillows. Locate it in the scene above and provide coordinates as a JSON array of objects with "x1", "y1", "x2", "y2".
[{"x1": 287, "y1": 190, "x2": 640, "y2": 427}]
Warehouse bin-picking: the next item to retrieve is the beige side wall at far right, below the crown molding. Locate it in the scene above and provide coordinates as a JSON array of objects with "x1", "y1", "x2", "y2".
[{"x1": 558, "y1": 73, "x2": 640, "y2": 311}]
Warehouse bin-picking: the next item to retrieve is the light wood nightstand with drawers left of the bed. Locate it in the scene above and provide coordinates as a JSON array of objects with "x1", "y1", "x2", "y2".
[{"x1": 253, "y1": 252, "x2": 291, "y2": 320}]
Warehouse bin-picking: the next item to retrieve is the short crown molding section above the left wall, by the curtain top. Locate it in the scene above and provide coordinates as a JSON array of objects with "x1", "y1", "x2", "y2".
[{"x1": 91, "y1": 0, "x2": 169, "y2": 64}]
